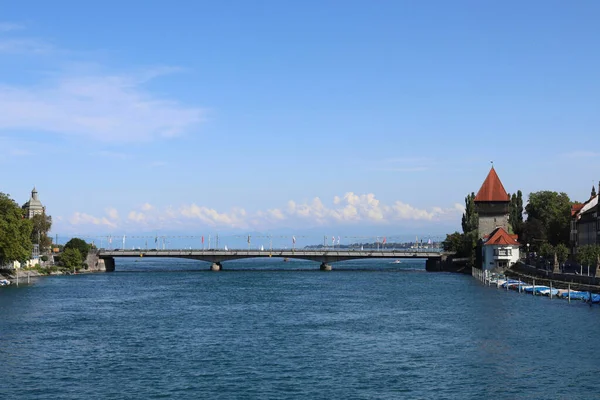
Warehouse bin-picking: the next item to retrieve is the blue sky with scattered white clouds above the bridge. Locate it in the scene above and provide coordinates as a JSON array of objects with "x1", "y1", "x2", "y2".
[{"x1": 0, "y1": 0, "x2": 600, "y2": 245}]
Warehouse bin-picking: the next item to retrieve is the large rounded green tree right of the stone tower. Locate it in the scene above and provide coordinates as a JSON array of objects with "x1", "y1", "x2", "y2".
[{"x1": 523, "y1": 190, "x2": 572, "y2": 246}]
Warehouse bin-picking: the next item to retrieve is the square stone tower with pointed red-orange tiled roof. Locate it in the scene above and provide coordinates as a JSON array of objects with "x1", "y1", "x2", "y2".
[{"x1": 474, "y1": 166, "x2": 510, "y2": 239}]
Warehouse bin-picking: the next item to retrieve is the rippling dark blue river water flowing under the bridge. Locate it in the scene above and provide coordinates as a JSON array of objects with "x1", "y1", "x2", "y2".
[{"x1": 0, "y1": 259, "x2": 600, "y2": 399}]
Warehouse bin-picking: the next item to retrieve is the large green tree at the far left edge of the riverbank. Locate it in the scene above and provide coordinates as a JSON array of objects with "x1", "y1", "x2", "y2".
[{"x1": 0, "y1": 193, "x2": 32, "y2": 266}]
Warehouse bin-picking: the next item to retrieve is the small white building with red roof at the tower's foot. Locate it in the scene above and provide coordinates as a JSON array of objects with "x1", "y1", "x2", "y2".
[{"x1": 482, "y1": 227, "x2": 521, "y2": 270}]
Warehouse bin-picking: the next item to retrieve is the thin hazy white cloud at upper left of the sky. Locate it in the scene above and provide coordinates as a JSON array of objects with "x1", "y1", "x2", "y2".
[{"x1": 0, "y1": 76, "x2": 204, "y2": 143}]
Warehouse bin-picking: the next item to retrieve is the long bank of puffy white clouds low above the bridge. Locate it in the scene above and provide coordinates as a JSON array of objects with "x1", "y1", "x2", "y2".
[{"x1": 62, "y1": 192, "x2": 464, "y2": 230}]
